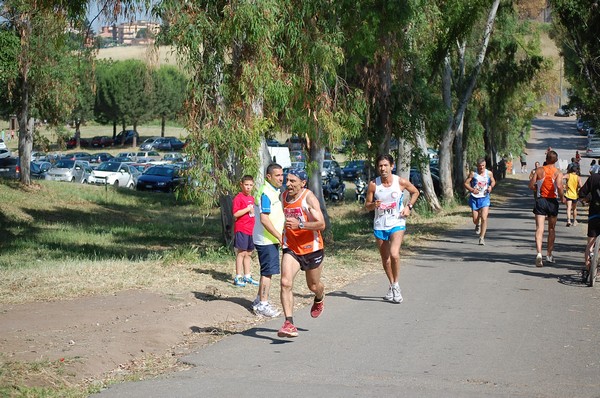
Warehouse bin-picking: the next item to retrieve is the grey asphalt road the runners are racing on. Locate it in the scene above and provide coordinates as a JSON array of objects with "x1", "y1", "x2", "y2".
[{"x1": 99, "y1": 117, "x2": 600, "y2": 397}]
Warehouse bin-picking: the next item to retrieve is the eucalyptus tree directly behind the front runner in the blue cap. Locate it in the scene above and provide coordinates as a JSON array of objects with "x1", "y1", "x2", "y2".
[{"x1": 281, "y1": 0, "x2": 365, "y2": 210}]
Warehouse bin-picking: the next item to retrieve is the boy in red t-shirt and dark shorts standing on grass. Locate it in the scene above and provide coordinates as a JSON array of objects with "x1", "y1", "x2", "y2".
[{"x1": 233, "y1": 175, "x2": 258, "y2": 287}]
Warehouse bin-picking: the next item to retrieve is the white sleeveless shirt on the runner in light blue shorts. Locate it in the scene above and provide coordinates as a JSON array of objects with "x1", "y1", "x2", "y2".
[{"x1": 373, "y1": 174, "x2": 406, "y2": 231}]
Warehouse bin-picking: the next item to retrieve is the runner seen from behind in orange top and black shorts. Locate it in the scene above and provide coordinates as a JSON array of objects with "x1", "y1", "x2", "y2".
[{"x1": 529, "y1": 150, "x2": 565, "y2": 267}]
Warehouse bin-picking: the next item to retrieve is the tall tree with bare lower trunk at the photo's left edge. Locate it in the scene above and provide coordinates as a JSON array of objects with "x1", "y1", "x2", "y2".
[{"x1": 0, "y1": 0, "x2": 146, "y2": 185}]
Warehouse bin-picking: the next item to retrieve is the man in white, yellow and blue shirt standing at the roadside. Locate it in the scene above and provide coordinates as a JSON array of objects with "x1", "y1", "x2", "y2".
[{"x1": 252, "y1": 163, "x2": 285, "y2": 318}]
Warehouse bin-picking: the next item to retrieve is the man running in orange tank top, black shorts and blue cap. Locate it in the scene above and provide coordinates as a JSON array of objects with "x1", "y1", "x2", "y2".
[{"x1": 277, "y1": 169, "x2": 325, "y2": 337}]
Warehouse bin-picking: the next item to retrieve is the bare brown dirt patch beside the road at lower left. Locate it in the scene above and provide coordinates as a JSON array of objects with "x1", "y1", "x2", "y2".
[{"x1": 0, "y1": 291, "x2": 260, "y2": 383}]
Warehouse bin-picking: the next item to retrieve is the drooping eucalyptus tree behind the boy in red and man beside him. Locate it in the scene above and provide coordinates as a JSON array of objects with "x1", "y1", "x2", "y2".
[{"x1": 154, "y1": 0, "x2": 290, "y2": 209}]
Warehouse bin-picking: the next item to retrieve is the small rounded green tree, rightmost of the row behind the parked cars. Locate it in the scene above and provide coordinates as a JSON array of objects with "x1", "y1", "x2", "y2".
[{"x1": 152, "y1": 65, "x2": 187, "y2": 137}]
